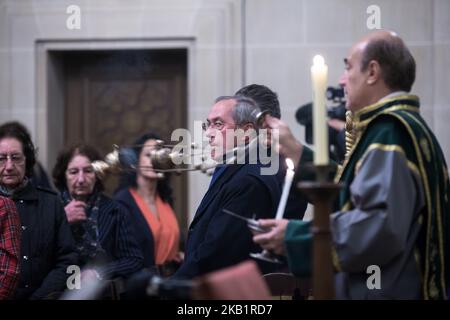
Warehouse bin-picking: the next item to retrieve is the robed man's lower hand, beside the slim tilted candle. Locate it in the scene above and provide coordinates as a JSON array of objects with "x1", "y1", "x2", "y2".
[{"x1": 253, "y1": 219, "x2": 289, "y2": 255}]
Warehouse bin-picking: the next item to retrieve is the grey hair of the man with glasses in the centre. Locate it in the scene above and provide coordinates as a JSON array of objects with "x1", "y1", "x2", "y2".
[{"x1": 215, "y1": 96, "x2": 260, "y2": 130}]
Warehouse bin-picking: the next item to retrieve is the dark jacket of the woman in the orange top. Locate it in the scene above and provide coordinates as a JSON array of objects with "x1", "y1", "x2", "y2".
[{"x1": 114, "y1": 188, "x2": 155, "y2": 268}]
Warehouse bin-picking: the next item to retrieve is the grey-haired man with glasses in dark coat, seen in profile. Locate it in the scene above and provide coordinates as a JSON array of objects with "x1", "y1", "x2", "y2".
[{"x1": 174, "y1": 96, "x2": 281, "y2": 279}]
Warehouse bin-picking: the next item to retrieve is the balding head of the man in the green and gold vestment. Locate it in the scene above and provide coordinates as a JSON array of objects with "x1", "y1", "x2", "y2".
[{"x1": 340, "y1": 30, "x2": 416, "y2": 111}]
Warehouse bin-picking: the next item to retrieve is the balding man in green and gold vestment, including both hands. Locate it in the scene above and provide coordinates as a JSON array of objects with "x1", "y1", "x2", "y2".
[{"x1": 254, "y1": 31, "x2": 450, "y2": 299}]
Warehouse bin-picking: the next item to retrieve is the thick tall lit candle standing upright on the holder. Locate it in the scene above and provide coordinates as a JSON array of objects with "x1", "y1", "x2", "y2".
[{"x1": 311, "y1": 55, "x2": 329, "y2": 165}]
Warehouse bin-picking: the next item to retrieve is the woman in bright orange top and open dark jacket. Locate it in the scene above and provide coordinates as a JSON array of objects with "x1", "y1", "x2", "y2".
[{"x1": 114, "y1": 133, "x2": 182, "y2": 275}]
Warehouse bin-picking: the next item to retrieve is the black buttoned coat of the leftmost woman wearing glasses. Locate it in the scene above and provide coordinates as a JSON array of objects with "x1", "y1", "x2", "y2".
[{"x1": 12, "y1": 183, "x2": 78, "y2": 299}]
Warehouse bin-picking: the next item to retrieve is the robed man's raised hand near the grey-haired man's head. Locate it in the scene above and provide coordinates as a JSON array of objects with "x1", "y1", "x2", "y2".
[{"x1": 263, "y1": 115, "x2": 303, "y2": 166}]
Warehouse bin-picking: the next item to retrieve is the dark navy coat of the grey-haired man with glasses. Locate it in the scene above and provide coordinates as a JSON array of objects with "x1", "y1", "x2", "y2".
[{"x1": 174, "y1": 164, "x2": 281, "y2": 279}]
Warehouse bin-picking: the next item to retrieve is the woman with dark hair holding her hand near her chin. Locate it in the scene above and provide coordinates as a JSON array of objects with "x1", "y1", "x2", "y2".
[{"x1": 53, "y1": 144, "x2": 142, "y2": 279}]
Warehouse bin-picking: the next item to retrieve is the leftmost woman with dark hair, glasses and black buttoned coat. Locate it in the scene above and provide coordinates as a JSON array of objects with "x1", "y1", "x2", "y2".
[{"x1": 0, "y1": 123, "x2": 78, "y2": 299}]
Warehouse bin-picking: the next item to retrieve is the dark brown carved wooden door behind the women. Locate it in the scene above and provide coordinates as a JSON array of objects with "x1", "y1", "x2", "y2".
[{"x1": 64, "y1": 50, "x2": 187, "y2": 227}]
